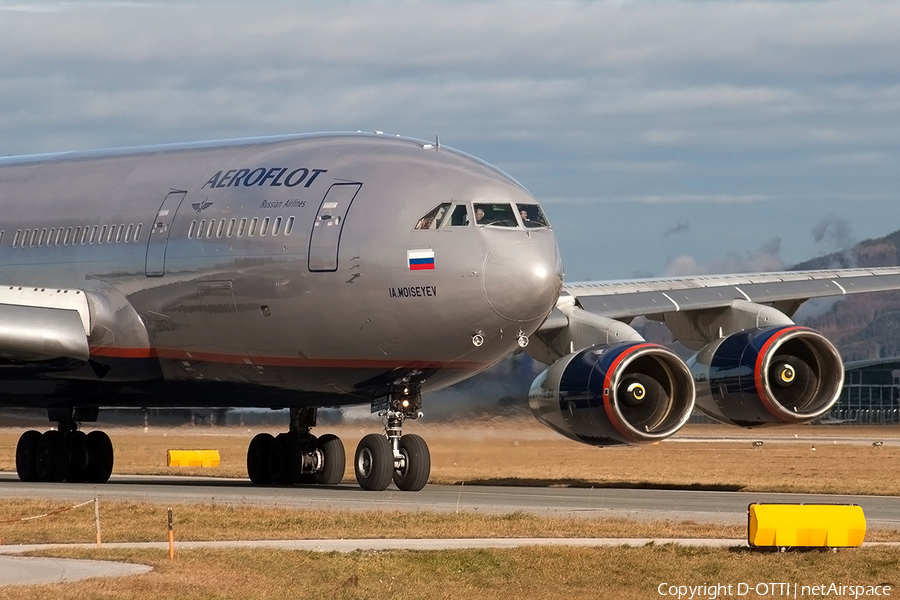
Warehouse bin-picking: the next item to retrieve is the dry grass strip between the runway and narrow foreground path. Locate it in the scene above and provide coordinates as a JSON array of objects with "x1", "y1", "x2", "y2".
[{"x1": 0, "y1": 500, "x2": 744, "y2": 545}]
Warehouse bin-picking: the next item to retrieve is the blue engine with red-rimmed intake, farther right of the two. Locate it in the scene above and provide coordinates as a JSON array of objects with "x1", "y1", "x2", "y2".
[{"x1": 688, "y1": 326, "x2": 844, "y2": 427}]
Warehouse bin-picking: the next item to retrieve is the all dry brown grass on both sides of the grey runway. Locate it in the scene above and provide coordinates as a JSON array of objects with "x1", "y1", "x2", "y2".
[{"x1": 0, "y1": 420, "x2": 900, "y2": 600}]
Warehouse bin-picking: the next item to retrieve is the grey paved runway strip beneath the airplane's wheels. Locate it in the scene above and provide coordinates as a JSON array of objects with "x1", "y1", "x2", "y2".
[{"x1": 0, "y1": 473, "x2": 900, "y2": 528}]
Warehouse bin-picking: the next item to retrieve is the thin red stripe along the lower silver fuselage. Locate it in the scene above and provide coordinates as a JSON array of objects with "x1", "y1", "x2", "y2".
[{"x1": 91, "y1": 346, "x2": 487, "y2": 369}]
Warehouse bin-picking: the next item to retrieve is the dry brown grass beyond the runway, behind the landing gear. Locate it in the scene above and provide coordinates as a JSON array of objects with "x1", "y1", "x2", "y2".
[{"x1": 7, "y1": 418, "x2": 900, "y2": 495}]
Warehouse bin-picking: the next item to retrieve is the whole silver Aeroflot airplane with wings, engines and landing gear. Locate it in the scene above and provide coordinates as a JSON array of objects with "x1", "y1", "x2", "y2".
[{"x1": 0, "y1": 132, "x2": 900, "y2": 491}]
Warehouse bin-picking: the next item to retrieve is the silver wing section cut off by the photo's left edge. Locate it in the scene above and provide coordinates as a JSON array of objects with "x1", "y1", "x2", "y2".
[{"x1": 0, "y1": 286, "x2": 90, "y2": 363}]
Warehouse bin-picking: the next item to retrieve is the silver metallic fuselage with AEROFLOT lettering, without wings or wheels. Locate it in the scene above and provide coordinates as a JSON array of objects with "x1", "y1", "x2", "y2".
[{"x1": 0, "y1": 134, "x2": 562, "y2": 407}]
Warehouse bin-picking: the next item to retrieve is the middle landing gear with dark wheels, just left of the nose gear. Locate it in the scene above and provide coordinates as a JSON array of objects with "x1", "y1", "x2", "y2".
[{"x1": 247, "y1": 407, "x2": 347, "y2": 485}]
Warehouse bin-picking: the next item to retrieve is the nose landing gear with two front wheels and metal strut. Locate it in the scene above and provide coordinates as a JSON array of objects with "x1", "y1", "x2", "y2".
[{"x1": 353, "y1": 386, "x2": 431, "y2": 492}]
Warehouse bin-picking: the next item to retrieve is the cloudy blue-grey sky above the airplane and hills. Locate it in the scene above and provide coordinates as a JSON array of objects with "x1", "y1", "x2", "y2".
[{"x1": 0, "y1": 0, "x2": 900, "y2": 281}]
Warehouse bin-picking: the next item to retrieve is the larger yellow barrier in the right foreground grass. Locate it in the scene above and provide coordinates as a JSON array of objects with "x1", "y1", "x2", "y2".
[{"x1": 747, "y1": 504, "x2": 866, "y2": 548}]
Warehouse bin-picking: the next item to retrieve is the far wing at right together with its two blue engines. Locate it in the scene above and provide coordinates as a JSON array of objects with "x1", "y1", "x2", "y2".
[{"x1": 528, "y1": 267, "x2": 900, "y2": 446}]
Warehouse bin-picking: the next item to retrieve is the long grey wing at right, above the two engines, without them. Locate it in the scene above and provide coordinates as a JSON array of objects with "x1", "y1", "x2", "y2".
[{"x1": 560, "y1": 267, "x2": 900, "y2": 328}]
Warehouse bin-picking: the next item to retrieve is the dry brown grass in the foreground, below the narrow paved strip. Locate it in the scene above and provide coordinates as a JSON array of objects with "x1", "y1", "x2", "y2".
[{"x1": 3, "y1": 546, "x2": 900, "y2": 600}]
